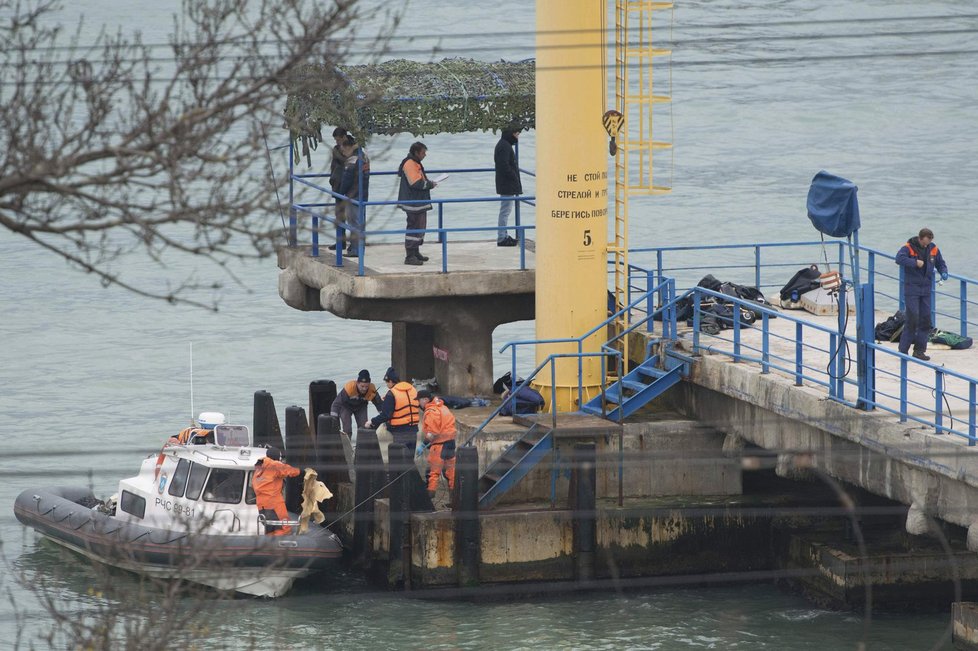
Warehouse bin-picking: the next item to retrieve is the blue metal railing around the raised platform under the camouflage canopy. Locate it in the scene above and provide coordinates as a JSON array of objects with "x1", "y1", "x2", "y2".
[{"x1": 288, "y1": 147, "x2": 536, "y2": 276}]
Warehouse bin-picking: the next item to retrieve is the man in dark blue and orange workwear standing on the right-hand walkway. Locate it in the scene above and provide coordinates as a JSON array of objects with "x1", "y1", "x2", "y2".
[{"x1": 896, "y1": 228, "x2": 947, "y2": 362}]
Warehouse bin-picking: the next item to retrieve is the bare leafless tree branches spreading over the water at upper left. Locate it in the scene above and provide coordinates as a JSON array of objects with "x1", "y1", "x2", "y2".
[{"x1": 0, "y1": 0, "x2": 398, "y2": 309}]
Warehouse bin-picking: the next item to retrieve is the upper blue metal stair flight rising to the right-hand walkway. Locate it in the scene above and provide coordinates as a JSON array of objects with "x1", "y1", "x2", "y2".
[{"x1": 581, "y1": 349, "x2": 693, "y2": 421}]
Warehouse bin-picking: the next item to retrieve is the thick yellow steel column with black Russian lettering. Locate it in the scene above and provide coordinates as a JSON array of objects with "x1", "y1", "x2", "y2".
[{"x1": 535, "y1": 0, "x2": 608, "y2": 410}]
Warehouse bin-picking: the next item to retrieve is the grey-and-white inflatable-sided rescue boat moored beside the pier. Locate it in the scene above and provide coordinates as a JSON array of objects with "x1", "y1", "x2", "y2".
[{"x1": 14, "y1": 424, "x2": 342, "y2": 597}]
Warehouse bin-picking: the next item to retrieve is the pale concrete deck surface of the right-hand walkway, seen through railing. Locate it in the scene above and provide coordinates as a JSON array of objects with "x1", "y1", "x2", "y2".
[{"x1": 683, "y1": 310, "x2": 978, "y2": 444}]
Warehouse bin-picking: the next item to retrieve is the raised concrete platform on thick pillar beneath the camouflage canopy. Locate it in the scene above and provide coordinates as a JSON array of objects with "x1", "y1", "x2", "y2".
[{"x1": 278, "y1": 241, "x2": 536, "y2": 396}]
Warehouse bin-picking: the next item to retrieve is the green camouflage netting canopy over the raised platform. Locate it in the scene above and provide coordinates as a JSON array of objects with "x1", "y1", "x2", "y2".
[{"x1": 285, "y1": 58, "x2": 536, "y2": 157}]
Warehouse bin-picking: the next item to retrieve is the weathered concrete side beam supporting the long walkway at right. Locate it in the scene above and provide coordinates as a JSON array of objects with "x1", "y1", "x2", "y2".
[{"x1": 666, "y1": 322, "x2": 978, "y2": 540}]
